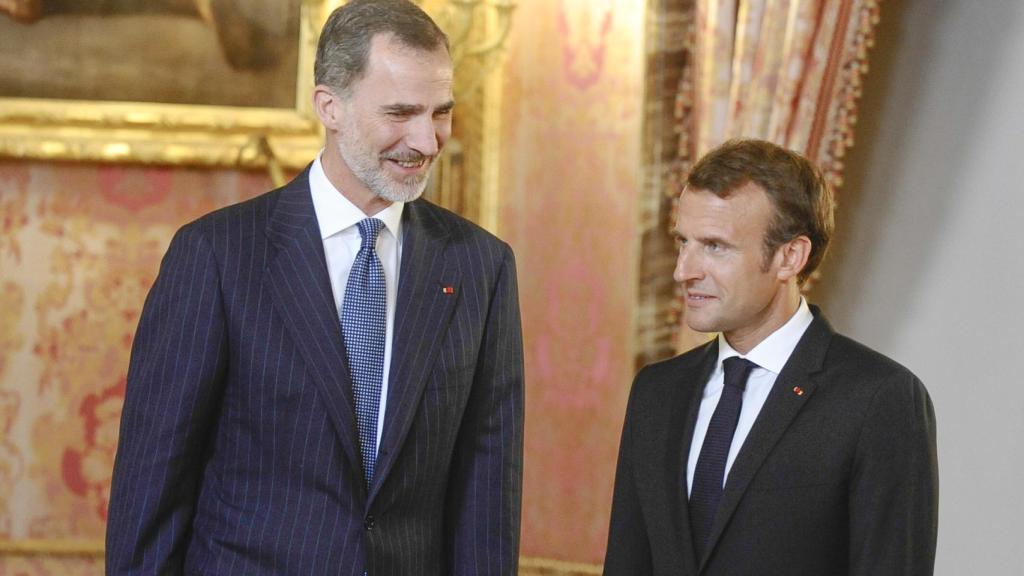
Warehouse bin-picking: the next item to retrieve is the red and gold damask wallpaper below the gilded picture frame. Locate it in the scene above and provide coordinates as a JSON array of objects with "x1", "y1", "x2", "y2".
[{"x1": 0, "y1": 162, "x2": 270, "y2": 575}]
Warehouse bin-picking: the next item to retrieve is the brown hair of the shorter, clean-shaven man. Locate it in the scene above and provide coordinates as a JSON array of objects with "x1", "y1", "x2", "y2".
[{"x1": 686, "y1": 138, "x2": 835, "y2": 284}]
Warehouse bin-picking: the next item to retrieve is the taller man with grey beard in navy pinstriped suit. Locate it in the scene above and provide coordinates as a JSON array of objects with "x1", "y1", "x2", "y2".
[{"x1": 106, "y1": 0, "x2": 523, "y2": 576}]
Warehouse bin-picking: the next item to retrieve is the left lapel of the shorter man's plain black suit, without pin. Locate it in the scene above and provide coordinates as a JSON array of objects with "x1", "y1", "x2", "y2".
[{"x1": 664, "y1": 338, "x2": 718, "y2": 574}]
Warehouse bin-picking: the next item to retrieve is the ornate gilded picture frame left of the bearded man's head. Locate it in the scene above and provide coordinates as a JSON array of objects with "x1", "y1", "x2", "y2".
[{"x1": 0, "y1": 0, "x2": 343, "y2": 170}]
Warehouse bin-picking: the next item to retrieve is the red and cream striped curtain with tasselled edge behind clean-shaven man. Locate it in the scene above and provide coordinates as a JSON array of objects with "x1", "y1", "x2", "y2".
[{"x1": 676, "y1": 0, "x2": 879, "y2": 351}]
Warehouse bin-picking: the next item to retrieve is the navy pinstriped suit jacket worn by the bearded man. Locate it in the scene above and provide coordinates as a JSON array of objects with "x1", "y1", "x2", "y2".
[{"x1": 106, "y1": 172, "x2": 523, "y2": 576}]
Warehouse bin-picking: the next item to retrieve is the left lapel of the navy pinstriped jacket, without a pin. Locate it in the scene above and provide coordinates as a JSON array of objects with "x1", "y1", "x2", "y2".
[{"x1": 264, "y1": 168, "x2": 364, "y2": 486}]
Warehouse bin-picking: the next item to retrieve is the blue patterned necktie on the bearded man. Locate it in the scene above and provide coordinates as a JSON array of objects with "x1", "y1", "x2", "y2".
[{"x1": 341, "y1": 218, "x2": 387, "y2": 489}]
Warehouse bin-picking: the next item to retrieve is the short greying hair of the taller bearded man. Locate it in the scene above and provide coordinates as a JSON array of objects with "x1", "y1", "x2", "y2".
[{"x1": 313, "y1": 0, "x2": 450, "y2": 93}]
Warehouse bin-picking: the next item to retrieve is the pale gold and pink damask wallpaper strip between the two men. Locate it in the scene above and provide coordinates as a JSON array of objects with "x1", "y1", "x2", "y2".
[{"x1": 499, "y1": 0, "x2": 645, "y2": 564}]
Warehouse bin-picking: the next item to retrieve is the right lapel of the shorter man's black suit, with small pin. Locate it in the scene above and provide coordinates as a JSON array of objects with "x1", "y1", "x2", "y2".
[{"x1": 700, "y1": 305, "x2": 834, "y2": 570}]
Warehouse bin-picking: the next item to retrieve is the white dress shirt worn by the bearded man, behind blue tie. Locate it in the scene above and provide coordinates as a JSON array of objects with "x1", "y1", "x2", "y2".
[{"x1": 309, "y1": 152, "x2": 406, "y2": 448}]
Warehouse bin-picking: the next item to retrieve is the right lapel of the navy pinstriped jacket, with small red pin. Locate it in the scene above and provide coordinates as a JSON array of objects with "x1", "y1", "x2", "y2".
[{"x1": 369, "y1": 200, "x2": 462, "y2": 502}]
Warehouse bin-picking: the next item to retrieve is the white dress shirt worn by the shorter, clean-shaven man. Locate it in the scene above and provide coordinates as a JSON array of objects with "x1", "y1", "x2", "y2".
[{"x1": 686, "y1": 298, "x2": 814, "y2": 494}]
